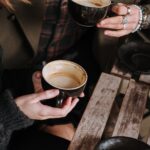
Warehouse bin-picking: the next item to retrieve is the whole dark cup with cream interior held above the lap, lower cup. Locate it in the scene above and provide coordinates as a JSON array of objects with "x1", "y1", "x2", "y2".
[{"x1": 42, "y1": 60, "x2": 88, "y2": 107}]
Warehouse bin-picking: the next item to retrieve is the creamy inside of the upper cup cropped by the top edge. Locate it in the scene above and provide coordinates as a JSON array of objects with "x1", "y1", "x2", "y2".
[{"x1": 72, "y1": 0, "x2": 110, "y2": 8}]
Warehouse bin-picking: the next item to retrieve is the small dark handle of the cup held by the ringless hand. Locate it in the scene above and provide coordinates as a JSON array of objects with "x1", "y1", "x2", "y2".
[{"x1": 56, "y1": 91, "x2": 67, "y2": 108}]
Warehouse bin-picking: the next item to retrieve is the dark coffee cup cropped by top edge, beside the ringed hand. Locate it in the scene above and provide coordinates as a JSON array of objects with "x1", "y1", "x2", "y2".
[{"x1": 68, "y1": 0, "x2": 111, "y2": 27}]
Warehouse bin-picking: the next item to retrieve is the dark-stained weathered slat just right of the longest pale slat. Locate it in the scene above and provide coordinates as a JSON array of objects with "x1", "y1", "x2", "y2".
[{"x1": 113, "y1": 80, "x2": 148, "y2": 138}]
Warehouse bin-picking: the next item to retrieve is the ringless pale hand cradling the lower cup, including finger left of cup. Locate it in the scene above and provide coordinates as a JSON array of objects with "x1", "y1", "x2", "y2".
[{"x1": 15, "y1": 72, "x2": 79, "y2": 120}]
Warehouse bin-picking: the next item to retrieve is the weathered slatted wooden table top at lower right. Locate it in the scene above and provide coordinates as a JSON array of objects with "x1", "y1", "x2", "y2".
[{"x1": 68, "y1": 63, "x2": 150, "y2": 150}]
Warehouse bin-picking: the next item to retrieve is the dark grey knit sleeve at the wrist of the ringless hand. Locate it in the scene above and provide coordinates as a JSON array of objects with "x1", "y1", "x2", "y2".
[{"x1": 0, "y1": 90, "x2": 33, "y2": 150}]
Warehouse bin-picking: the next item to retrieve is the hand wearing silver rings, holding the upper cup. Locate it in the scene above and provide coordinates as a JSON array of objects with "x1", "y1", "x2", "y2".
[{"x1": 97, "y1": 3, "x2": 140, "y2": 37}]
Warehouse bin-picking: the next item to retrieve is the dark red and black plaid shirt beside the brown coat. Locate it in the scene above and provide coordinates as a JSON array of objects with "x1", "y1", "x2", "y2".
[{"x1": 36, "y1": 0, "x2": 87, "y2": 62}]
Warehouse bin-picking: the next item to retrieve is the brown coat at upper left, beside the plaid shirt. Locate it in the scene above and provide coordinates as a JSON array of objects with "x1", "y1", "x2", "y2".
[{"x1": 0, "y1": 0, "x2": 45, "y2": 69}]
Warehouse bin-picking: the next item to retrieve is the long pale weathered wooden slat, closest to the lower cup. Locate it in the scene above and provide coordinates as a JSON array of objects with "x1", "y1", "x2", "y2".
[{"x1": 69, "y1": 73, "x2": 121, "y2": 150}]
